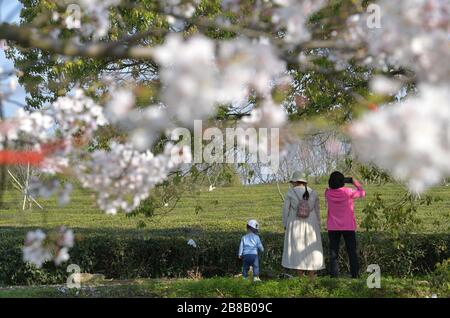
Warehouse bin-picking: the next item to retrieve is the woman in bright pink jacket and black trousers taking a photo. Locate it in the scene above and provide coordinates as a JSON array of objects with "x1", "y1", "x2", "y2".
[{"x1": 325, "y1": 171, "x2": 366, "y2": 278}]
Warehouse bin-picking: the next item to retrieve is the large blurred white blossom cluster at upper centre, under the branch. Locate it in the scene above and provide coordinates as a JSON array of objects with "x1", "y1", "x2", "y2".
[{"x1": 105, "y1": 34, "x2": 290, "y2": 150}]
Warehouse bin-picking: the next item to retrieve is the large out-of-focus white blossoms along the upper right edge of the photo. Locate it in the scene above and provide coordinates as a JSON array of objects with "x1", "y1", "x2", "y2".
[{"x1": 346, "y1": 0, "x2": 450, "y2": 192}]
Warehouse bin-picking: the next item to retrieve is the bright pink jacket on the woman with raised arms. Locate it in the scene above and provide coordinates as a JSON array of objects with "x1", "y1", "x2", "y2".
[{"x1": 325, "y1": 180, "x2": 366, "y2": 231}]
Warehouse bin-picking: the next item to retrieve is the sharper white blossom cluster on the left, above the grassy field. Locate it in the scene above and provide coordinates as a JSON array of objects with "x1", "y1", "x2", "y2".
[{"x1": 2, "y1": 89, "x2": 191, "y2": 214}]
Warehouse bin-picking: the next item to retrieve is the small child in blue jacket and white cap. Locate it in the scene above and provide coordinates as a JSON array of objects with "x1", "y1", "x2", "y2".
[{"x1": 239, "y1": 220, "x2": 264, "y2": 281}]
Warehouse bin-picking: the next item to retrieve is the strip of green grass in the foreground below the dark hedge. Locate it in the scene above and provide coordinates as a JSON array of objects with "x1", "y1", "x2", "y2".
[{"x1": 0, "y1": 277, "x2": 442, "y2": 298}]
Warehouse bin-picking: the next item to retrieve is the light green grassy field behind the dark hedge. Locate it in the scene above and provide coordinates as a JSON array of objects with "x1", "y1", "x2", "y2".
[{"x1": 0, "y1": 184, "x2": 450, "y2": 235}]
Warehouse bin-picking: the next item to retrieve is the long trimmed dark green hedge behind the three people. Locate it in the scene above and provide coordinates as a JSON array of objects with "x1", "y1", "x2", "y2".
[{"x1": 0, "y1": 231, "x2": 450, "y2": 285}]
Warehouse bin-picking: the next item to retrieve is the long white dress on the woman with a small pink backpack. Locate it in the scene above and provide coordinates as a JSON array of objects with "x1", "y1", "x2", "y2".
[{"x1": 281, "y1": 186, "x2": 325, "y2": 271}]
